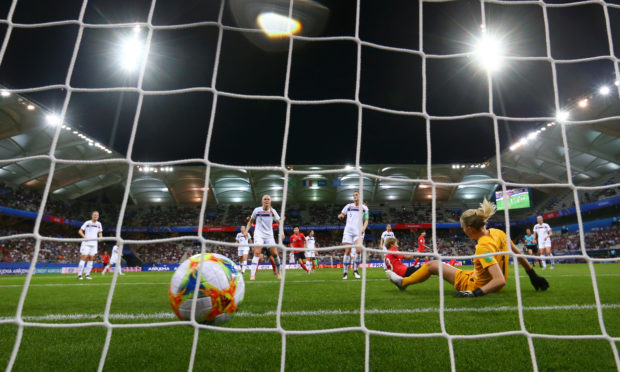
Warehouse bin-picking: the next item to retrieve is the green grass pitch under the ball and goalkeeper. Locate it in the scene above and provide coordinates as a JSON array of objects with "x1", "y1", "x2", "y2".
[{"x1": 0, "y1": 264, "x2": 620, "y2": 371}]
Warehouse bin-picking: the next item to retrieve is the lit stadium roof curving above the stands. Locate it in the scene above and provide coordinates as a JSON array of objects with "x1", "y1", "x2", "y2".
[{"x1": 0, "y1": 90, "x2": 620, "y2": 205}]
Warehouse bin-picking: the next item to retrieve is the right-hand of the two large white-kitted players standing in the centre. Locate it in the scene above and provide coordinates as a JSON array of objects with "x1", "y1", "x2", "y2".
[{"x1": 338, "y1": 191, "x2": 368, "y2": 280}]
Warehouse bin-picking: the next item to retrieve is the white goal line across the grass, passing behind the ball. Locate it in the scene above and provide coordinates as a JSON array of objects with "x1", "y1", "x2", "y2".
[{"x1": 0, "y1": 304, "x2": 620, "y2": 322}]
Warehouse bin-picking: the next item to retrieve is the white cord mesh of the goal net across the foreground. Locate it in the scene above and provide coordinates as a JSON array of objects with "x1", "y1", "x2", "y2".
[{"x1": 0, "y1": 0, "x2": 620, "y2": 371}]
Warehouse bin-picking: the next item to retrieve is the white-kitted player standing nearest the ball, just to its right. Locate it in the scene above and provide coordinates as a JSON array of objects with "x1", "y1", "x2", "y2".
[{"x1": 245, "y1": 195, "x2": 284, "y2": 280}]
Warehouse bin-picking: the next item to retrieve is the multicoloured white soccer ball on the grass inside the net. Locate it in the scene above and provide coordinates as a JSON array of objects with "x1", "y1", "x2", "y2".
[{"x1": 168, "y1": 253, "x2": 245, "y2": 325}]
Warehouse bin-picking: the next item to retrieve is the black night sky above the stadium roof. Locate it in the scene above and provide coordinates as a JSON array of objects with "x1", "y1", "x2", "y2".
[{"x1": 0, "y1": 0, "x2": 620, "y2": 165}]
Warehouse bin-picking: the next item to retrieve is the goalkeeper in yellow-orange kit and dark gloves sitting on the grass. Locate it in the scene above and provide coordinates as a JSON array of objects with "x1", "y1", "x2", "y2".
[{"x1": 386, "y1": 199, "x2": 549, "y2": 297}]
